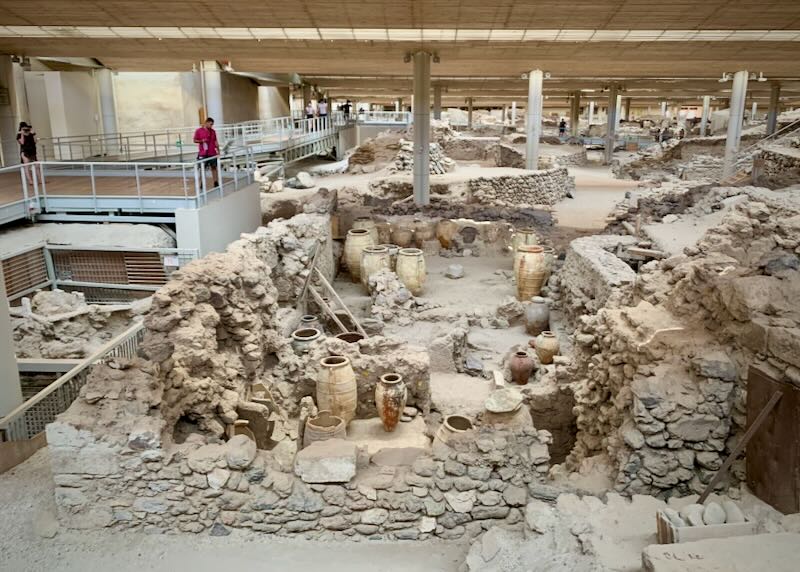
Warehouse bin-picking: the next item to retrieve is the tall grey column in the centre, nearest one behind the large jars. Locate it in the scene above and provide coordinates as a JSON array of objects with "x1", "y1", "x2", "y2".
[{"x1": 414, "y1": 51, "x2": 431, "y2": 207}]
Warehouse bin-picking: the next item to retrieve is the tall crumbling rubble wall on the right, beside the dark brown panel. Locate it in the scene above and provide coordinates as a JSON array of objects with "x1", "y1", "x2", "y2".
[{"x1": 568, "y1": 188, "x2": 800, "y2": 495}]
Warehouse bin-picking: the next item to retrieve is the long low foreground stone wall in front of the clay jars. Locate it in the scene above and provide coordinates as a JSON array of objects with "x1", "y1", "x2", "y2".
[{"x1": 47, "y1": 354, "x2": 550, "y2": 539}]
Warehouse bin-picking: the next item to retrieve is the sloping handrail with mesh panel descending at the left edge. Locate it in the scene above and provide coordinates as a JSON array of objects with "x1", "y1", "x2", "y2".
[{"x1": 0, "y1": 321, "x2": 144, "y2": 441}]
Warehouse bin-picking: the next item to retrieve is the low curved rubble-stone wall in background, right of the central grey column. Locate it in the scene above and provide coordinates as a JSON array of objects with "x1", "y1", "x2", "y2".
[{"x1": 469, "y1": 167, "x2": 575, "y2": 207}]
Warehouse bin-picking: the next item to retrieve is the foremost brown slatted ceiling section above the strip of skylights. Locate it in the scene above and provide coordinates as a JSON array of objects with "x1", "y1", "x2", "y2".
[{"x1": 0, "y1": 0, "x2": 800, "y2": 30}]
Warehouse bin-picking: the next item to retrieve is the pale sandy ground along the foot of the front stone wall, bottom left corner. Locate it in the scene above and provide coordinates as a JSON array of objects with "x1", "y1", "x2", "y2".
[{"x1": 0, "y1": 449, "x2": 468, "y2": 572}]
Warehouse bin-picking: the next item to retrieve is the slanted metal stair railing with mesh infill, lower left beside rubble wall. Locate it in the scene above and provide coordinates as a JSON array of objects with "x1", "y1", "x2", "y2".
[{"x1": 0, "y1": 321, "x2": 144, "y2": 441}]
